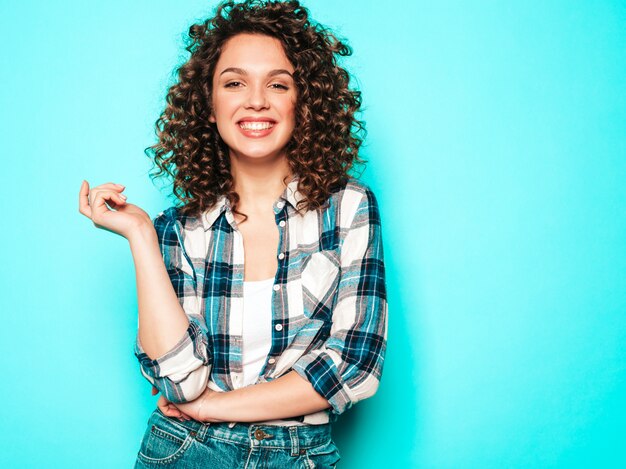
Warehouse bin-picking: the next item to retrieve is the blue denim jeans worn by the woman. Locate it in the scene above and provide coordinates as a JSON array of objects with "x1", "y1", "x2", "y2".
[{"x1": 135, "y1": 408, "x2": 341, "y2": 469}]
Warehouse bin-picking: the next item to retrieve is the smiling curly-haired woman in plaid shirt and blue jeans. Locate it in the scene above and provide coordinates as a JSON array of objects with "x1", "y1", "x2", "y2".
[{"x1": 80, "y1": 0, "x2": 387, "y2": 468}]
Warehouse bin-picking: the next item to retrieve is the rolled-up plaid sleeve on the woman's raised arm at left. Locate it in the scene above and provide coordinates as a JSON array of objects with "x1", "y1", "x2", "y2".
[{"x1": 134, "y1": 208, "x2": 212, "y2": 403}]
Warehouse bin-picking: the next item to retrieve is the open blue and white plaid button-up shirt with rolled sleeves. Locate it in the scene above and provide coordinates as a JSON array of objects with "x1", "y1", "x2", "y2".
[{"x1": 135, "y1": 177, "x2": 387, "y2": 425}]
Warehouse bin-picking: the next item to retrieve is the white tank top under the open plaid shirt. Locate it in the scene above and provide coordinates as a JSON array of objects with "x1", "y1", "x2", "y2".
[{"x1": 242, "y1": 277, "x2": 305, "y2": 425}]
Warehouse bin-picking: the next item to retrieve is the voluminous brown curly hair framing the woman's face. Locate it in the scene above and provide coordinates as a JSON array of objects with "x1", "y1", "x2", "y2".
[{"x1": 145, "y1": 0, "x2": 367, "y2": 222}]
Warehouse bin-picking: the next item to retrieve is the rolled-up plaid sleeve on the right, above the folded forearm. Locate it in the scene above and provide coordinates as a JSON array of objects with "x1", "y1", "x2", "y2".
[{"x1": 292, "y1": 187, "x2": 387, "y2": 415}]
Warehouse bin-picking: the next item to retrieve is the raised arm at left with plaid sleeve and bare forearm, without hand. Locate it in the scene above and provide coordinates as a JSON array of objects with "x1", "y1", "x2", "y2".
[{"x1": 129, "y1": 211, "x2": 211, "y2": 402}]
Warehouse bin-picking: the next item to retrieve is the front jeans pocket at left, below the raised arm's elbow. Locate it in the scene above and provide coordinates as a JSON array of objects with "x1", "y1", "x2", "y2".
[{"x1": 137, "y1": 410, "x2": 194, "y2": 465}]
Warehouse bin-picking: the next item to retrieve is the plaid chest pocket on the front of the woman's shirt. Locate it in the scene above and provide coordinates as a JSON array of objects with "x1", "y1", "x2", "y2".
[{"x1": 301, "y1": 249, "x2": 341, "y2": 322}]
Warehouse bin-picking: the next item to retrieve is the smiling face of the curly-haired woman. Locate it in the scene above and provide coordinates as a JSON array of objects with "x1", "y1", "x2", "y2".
[{"x1": 209, "y1": 34, "x2": 296, "y2": 160}]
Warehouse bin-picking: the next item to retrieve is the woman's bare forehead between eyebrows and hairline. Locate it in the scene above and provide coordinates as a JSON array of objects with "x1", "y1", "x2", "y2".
[{"x1": 216, "y1": 33, "x2": 294, "y2": 74}]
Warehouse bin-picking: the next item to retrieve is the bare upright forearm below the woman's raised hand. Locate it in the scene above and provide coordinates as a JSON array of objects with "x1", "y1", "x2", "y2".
[{"x1": 129, "y1": 226, "x2": 189, "y2": 359}]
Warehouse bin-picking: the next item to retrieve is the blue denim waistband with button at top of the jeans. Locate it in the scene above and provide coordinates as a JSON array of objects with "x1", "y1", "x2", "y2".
[{"x1": 148, "y1": 408, "x2": 331, "y2": 454}]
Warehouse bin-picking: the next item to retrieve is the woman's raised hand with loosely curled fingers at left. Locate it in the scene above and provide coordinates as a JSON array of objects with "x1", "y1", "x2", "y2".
[{"x1": 78, "y1": 181, "x2": 152, "y2": 239}]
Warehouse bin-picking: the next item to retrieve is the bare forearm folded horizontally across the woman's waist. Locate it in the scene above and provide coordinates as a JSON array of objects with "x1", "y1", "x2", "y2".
[{"x1": 208, "y1": 371, "x2": 330, "y2": 422}]
